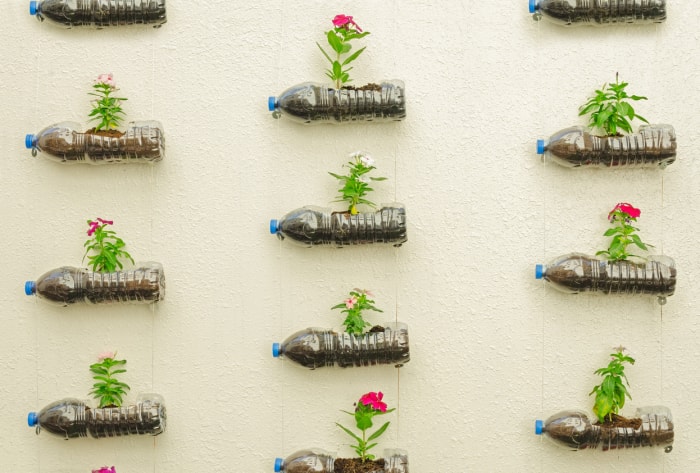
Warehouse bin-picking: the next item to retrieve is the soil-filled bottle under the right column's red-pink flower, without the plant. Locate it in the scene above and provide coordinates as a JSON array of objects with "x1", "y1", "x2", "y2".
[{"x1": 535, "y1": 253, "x2": 676, "y2": 304}]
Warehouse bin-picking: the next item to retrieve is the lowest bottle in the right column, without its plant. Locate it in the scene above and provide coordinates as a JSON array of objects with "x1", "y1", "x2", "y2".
[{"x1": 535, "y1": 406, "x2": 673, "y2": 453}]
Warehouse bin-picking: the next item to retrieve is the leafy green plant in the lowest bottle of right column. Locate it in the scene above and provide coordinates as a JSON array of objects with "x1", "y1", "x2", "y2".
[{"x1": 589, "y1": 346, "x2": 634, "y2": 424}]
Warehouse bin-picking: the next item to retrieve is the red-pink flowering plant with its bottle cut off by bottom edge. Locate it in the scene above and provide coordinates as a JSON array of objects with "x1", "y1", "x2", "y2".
[{"x1": 275, "y1": 391, "x2": 408, "y2": 473}]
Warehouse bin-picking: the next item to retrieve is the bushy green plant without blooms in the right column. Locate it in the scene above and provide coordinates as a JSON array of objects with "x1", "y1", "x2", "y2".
[{"x1": 579, "y1": 74, "x2": 649, "y2": 136}]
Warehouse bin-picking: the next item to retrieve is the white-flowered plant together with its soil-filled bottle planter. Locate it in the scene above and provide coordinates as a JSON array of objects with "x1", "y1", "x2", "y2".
[{"x1": 270, "y1": 151, "x2": 407, "y2": 248}]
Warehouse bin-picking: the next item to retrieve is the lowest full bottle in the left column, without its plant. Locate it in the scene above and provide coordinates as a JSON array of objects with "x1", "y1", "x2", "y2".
[{"x1": 27, "y1": 394, "x2": 166, "y2": 440}]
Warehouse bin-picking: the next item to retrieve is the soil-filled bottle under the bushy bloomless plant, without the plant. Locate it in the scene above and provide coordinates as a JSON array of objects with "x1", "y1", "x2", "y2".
[{"x1": 537, "y1": 125, "x2": 676, "y2": 169}]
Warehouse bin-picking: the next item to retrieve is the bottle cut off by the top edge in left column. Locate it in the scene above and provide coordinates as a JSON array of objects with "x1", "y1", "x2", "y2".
[{"x1": 29, "y1": 0, "x2": 167, "y2": 28}]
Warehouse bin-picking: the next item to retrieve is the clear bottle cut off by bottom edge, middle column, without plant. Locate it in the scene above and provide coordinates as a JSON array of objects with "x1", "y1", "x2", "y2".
[{"x1": 275, "y1": 448, "x2": 408, "y2": 473}]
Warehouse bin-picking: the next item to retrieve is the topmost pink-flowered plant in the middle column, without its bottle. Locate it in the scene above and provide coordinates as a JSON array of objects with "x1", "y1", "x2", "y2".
[{"x1": 316, "y1": 15, "x2": 369, "y2": 88}]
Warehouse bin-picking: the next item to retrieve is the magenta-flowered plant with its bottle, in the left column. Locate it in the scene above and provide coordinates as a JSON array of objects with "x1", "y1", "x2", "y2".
[{"x1": 24, "y1": 218, "x2": 165, "y2": 306}]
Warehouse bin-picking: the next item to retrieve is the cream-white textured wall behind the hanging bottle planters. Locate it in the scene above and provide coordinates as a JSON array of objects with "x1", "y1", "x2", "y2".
[{"x1": 0, "y1": 0, "x2": 700, "y2": 473}]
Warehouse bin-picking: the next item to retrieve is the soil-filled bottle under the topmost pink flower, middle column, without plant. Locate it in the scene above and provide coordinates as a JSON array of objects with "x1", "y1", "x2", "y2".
[{"x1": 268, "y1": 80, "x2": 406, "y2": 124}]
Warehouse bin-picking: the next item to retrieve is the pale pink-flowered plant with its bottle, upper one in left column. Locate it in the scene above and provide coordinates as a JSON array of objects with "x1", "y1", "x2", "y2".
[{"x1": 25, "y1": 74, "x2": 165, "y2": 164}]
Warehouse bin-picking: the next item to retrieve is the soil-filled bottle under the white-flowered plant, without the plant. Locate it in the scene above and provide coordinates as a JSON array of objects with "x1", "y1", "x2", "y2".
[{"x1": 270, "y1": 203, "x2": 407, "y2": 247}]
